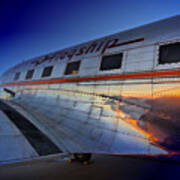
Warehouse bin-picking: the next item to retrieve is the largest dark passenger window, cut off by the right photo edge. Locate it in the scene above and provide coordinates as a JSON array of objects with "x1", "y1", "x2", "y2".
[{"x1": 159, "y1": 42, "x2": 180, "y2": 64}]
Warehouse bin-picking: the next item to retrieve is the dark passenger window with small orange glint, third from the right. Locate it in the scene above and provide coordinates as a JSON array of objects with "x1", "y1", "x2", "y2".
[{"x1": 64, "y1": 61, "x2": 80, "y2": 75}]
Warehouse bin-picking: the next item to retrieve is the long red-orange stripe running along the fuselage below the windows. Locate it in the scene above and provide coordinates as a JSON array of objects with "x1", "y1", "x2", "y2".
[{"x1": 0, "y1": 70, "x2": 180, "y2": 87}]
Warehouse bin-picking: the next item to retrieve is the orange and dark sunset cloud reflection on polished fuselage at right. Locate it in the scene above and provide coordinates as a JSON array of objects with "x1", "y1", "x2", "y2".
[{"x1": 112, "y1": 80, "x2": 180, "y2": 152}]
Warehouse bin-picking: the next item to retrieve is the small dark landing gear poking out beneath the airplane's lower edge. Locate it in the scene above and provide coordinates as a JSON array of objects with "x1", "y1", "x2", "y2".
[{"x1": 68, "y1": 153, "x2": 92, "y2": 165}]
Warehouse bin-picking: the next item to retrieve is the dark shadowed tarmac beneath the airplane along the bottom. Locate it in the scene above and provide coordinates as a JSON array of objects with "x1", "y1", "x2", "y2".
[{"x1": 0, "y1": 154, "x2": 180, "y2": 180}]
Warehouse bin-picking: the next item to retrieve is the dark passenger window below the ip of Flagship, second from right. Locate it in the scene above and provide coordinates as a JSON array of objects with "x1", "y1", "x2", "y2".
[{"x1": 100, "y1": 53, "x2": 123, "y2": 71}]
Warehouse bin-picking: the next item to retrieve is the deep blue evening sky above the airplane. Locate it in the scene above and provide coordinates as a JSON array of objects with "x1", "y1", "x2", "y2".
[{"x1": 0, "y1": 0, "x2": 180, "y2": 74}]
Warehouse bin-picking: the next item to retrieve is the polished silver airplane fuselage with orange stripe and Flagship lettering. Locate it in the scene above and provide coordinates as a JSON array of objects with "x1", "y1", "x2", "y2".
[{"x1": 0, "y1": 15, "x2": 180, "y2": 162}]
